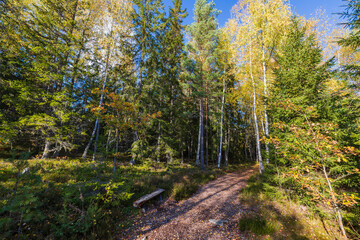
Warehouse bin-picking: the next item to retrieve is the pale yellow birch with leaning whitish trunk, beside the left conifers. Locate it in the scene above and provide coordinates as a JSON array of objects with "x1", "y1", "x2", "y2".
[{"x1": 82, "y1": 0, "x2": 132, "y2": 160}]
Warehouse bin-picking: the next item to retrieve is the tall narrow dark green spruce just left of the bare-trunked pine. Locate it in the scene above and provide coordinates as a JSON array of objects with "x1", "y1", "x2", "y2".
[{"x1": 156, "y1": 0, "x2": 187, "y2": 160}]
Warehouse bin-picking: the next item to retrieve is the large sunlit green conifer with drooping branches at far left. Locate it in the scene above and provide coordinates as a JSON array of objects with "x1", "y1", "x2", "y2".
[{"x1": 3, "y1": 0, "x2": 93, "y2": 158}]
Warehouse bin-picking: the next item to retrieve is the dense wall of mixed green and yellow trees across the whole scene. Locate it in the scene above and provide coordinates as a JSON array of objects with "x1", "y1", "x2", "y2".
[{"x1": 0, "y1": 0, "x2": 360, "y2": 235}]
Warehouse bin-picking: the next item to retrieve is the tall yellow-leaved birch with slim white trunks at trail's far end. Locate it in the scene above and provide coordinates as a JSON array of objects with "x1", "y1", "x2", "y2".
[{"x1": 228, "y1": 0, "x2": 290, "y2": 168}]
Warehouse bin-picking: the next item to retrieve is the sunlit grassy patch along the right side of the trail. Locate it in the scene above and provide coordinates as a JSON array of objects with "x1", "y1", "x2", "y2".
[{"x1": 238, "y1": 168, "x2": 348, "y2": 240}]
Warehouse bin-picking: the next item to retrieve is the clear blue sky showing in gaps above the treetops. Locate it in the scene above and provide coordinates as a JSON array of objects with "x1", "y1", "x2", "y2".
[{"x1": 165, "y1": 0, "x2": 344, "y2": 26}]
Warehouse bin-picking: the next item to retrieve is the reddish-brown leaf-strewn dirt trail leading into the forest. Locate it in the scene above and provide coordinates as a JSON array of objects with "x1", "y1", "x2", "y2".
[{"x1": 119, "y1": 166, "x2": 258, "y2": 240}]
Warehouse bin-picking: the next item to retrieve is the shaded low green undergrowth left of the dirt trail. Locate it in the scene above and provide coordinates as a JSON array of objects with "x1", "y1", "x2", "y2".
[{"x1": 0, "y1": 159, "x2": 248, "y2": 239}]
